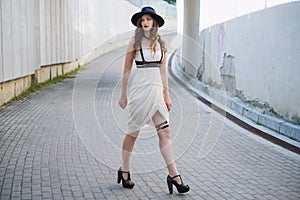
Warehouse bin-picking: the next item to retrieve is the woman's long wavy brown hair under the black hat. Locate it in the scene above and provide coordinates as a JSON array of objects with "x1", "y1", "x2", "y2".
[{"x1": 132, "y1": 17, "x2": 167, "y2": 57}]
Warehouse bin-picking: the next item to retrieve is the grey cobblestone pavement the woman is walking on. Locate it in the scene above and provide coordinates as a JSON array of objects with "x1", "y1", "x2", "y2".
[{"x1": 0, "y1": 41, "x2": 300, "y2": 199}]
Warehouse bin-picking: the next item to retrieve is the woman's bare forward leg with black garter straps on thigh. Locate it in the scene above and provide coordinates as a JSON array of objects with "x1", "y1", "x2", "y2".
[{"x1": 152, "y1": 112, "x2": 181, "y2": 184}]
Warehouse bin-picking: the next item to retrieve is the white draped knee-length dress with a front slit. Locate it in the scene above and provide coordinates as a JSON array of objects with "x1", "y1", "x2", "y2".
[{"x1": 128, "y1": 38, "x2": 169, "y2": 133}]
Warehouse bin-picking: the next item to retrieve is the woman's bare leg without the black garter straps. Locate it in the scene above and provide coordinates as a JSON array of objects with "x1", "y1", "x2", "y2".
[{"x1": 122, "y1": 131, "x2": 139, "y2": 179}]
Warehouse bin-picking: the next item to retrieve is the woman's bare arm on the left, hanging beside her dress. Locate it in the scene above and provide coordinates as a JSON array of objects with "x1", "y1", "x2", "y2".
[{"x1": 119, "y1": 39, "x2": 134, "y2": 109}]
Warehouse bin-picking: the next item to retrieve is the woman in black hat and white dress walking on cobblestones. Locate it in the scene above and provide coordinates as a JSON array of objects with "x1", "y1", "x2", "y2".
[{"x1": 117, "y1": 7, "x2": 189, "y2": 194}]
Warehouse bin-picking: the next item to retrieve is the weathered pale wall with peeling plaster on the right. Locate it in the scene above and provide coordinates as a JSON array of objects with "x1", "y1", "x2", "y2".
[{"x1": 199, "y1": 1, "x2": 300, "y2": 119}]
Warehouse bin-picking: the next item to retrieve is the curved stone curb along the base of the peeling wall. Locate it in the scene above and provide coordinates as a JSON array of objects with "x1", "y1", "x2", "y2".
[{"x1": 168, "y1": 51, "x2": 300, "y2": 154}]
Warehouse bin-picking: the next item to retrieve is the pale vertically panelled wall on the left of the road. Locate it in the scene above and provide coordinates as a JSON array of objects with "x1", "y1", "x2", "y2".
[{"x1": 0, "y1": 0, "x2": 137, "y2": 83}]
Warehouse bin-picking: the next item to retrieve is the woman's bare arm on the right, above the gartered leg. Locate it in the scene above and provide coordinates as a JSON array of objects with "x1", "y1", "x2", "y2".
[{"x1": 160, "y1": 51, "x2": 172, "y2": 111}]
